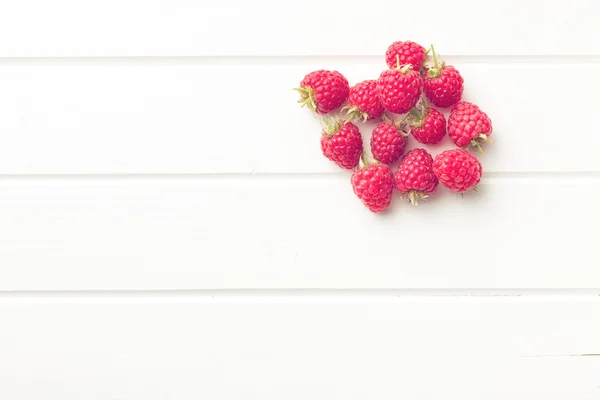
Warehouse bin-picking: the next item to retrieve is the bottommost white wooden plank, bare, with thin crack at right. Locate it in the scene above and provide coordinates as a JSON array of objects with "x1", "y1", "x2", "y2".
[{"x1": 0, "y1": 297, "x2": 600, "y2": 400}]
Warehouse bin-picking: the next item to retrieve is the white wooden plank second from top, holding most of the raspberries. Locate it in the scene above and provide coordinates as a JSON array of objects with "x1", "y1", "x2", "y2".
[{"x1": 0, "y1": 61, "x2": 600, "y2": 174}]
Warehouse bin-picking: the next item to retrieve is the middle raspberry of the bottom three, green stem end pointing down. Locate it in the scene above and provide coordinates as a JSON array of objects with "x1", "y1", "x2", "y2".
[{"x1": 394, "y1": 149, "x2": 438, "y2": 206}]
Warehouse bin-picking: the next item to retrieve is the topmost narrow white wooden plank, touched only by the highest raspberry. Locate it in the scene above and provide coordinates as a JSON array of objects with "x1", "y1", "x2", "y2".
[{"x1": 0, "y1": 0, "x2": 600, "y2": 57}]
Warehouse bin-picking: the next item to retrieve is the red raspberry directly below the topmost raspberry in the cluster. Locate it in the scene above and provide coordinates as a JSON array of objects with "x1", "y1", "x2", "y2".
[{"x1": 377, "y1": 65, "x2": 423, "y2": 114}]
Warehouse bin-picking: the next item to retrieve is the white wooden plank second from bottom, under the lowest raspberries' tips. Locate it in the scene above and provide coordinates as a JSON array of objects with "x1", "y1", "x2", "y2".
[{"x1": 0, "y1": 175, "x2": 600, "y2": 291}]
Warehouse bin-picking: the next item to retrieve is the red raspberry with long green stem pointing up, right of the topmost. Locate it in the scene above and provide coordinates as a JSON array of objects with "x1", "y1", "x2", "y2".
[{"x1": 423, "y1": 46, "x2": 464, "y2": 107}]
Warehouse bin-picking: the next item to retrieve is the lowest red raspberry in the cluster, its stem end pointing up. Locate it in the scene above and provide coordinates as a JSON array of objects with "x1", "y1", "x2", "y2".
[{"x1": 350, "y1": 156, "x2": 394, "y2": 212}]
